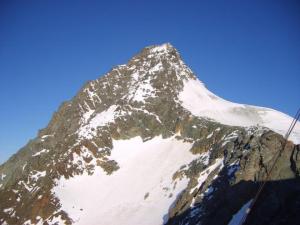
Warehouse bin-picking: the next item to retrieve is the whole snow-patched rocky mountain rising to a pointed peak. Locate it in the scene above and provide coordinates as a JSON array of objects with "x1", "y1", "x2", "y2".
[{"x1": 0, "y1": 44, "x2": 300, "y2": 225}]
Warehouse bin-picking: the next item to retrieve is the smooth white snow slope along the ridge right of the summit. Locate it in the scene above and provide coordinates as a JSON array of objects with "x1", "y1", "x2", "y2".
[{"x1": 178, "y1": 79, "x2": 300, "y2": 144}]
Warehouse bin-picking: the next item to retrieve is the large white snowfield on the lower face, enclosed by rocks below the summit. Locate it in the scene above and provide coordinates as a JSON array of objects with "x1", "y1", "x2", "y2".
[{"x1": 53, "y1": 137, "x2": 196, "y2": 225}]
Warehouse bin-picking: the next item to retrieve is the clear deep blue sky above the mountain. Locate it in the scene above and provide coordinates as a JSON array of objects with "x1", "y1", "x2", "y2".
[{"x1": 0, "y1": 0, "x2": 300, "y2": 163}]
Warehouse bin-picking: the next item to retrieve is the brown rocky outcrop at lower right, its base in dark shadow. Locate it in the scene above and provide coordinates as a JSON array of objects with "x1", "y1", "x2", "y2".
[{"x1": 167, "y1": 131, "x2": 300, "y2": 224}]
